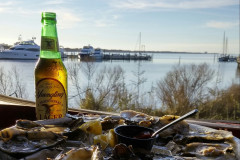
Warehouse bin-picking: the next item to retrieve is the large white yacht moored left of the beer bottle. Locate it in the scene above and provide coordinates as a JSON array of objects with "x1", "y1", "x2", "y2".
[{"x1": 0, "y1": 40, "x2": 40, "y2": 59}]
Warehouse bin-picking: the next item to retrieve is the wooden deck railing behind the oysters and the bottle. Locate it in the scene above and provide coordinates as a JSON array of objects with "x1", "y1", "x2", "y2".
[{"x1": 0, "y1": 95, "x2": 240, "y2": 138}]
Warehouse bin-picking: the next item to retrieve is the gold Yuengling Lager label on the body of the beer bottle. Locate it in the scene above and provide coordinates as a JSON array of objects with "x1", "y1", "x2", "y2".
[{"x1": 36, "y1": 78, "x2": 67, "y2": 119}]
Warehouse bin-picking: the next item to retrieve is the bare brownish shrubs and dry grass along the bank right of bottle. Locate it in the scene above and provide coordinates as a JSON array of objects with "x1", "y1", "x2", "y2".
[{"x1": 69, "y1": 62, "x2": 240, "y2": 120}]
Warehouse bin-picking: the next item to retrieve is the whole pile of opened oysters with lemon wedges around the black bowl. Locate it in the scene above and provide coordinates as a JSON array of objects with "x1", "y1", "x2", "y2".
[{"x1": 0, "y1": 110, "x2": 240, "y2": 160}]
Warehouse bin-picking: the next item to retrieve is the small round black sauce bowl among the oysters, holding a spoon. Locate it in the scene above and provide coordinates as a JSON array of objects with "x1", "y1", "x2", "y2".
[{"x1": 114, "y1": 125, "x2": 155, "y2": 151}]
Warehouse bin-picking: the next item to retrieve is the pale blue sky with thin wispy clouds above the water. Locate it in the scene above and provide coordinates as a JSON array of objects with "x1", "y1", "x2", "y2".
[{"x1": 0, "y1": 0, "x2": 239, "y2": 54}]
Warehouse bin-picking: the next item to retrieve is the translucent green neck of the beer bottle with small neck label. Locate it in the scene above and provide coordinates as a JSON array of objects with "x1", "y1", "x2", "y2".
[{"x1": 40, "y1": 18, "x2": 61, "y2": 59}]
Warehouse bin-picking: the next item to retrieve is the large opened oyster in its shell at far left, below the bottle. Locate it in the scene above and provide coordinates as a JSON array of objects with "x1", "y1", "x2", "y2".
[{"x1": 0, "y1": 120, "x2": 65, "y2": 155}]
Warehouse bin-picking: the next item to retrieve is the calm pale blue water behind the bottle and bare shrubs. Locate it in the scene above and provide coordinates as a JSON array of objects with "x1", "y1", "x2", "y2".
[{"x1": 0, "y1": 53, "x2": 240, "y2": 107}]
